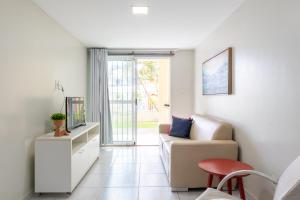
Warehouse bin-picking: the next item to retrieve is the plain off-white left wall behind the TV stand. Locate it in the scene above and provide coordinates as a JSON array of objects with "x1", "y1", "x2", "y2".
[{"x1": 0, "y1": 0, "x2": 86, "y2": 200}]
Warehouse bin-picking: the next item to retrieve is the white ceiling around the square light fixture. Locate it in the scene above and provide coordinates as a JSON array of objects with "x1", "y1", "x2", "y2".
[{"x1": 34, "y1": 0, "x2": 243, "y2": 48}]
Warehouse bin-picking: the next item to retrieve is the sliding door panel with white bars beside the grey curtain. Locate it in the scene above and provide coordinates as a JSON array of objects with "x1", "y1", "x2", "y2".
[{"x1": 108, "y1": 56, "x2": 137, "y2": 145}]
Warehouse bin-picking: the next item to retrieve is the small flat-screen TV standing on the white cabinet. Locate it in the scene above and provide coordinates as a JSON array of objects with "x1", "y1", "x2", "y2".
[{"x1": 66, "y1": 97, "x2": 86, "y2": 132}]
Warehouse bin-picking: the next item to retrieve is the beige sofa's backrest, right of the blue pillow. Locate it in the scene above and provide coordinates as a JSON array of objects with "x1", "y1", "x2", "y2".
[{"x1": 190, "y1": 115, "x2": 232, "y2": 140}]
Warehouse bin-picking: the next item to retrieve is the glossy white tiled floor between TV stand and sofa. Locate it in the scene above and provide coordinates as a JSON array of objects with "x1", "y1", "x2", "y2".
[{"x1": 32, "y1": 146, "x2": 237, "y2": 200}]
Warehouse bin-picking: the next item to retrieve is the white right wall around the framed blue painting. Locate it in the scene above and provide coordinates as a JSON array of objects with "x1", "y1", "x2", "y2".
[{"x1": 195, "y1": 0, "x2": 300, "y2": 200}]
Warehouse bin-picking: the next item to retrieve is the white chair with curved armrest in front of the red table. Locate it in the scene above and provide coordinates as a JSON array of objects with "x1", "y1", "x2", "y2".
[{"x1": 196, "y1": 156, "x2": 300, "y2": 200}]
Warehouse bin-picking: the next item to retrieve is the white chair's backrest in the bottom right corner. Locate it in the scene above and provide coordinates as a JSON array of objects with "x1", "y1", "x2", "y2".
[{"x1": 274, "y1": 156, "x2": 300, "y2": 200}]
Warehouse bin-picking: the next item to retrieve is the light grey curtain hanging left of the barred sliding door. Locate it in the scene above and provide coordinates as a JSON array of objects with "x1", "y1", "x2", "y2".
[{"x1": 88, "y1": 48, "x2": 112, "y2": 145}]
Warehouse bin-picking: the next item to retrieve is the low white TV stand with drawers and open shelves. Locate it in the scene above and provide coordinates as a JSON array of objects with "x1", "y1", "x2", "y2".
[{"x1": 35, "y1": 123, "x2": 100, "y2": 193}]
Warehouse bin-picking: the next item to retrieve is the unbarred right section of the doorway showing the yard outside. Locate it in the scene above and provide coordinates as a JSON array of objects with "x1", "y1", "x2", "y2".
[{"x1": 136, "y1": 57, "x2": 170, "y2": 145}]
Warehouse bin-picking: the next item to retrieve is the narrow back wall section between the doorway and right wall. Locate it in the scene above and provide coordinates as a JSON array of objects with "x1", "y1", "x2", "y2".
[{"x1": 170, "y1": 50, "x2": 195, "y2": 117}]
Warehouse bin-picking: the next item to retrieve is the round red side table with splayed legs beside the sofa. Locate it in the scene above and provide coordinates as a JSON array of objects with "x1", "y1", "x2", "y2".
[{"x1": 198, "y1": 159, "x2": 253, "y2": 200}]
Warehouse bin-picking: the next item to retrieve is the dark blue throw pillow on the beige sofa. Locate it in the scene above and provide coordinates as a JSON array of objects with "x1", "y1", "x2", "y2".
[{"x1": 170, "y1": 116, "x2": 193, "y2": 138}]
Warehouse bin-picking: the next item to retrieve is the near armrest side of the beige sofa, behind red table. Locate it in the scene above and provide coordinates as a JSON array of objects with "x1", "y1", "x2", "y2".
[{"x1": 170, "y1": 140, "x2": 238, "y2": 188}]
